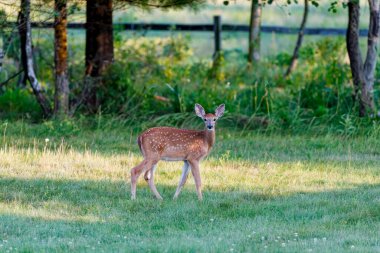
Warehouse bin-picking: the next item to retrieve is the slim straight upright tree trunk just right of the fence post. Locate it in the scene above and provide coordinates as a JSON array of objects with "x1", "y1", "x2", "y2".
[{"x1": 248, "y1": 0, "x2": 261, "y2": 63}]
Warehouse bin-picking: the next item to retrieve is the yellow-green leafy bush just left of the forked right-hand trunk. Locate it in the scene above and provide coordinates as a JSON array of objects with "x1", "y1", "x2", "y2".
[{"x1": 291, "y1": 39, "x2": 353, "y2": 117}]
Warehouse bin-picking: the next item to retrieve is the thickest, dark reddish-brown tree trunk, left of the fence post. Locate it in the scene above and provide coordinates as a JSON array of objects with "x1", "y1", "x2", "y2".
[{"x1": 86, "y1": 0, "x2": 113, "y2": 112}]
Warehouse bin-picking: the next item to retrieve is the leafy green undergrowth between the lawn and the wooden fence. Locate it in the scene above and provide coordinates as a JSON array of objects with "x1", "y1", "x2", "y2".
[{"x1": 2, "y1": 31, "x2": 380, "y2": 135}]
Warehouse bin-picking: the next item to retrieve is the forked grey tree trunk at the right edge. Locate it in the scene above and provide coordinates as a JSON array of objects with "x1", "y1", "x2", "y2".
[{"x1": 346, "y1": 0, "x2": 379, "y2": 117}]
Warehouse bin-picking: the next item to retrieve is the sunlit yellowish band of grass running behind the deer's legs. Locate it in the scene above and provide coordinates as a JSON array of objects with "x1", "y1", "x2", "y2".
[{"x1": 0, "y1": 143, "x2": 380, "y2": 195}]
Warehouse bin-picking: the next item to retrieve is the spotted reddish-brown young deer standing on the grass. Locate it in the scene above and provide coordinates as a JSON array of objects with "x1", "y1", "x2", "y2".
[{"x1": 131, "y1": 104, "x2": 224, "y2": 200}]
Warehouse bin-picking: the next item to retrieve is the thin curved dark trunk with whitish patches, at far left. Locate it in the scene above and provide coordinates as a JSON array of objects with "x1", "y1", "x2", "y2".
[{"x1": 20, "y1": 0, "x2": 52, "y2": 117}]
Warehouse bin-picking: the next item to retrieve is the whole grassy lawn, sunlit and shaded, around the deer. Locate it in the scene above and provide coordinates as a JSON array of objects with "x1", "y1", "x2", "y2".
[{"x1": 0, "y1": 122, "x2": 380, "y2": 252}]
